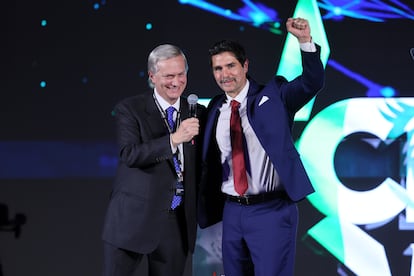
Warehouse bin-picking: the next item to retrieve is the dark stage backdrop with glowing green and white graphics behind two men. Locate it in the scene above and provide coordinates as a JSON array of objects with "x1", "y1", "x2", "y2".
[{"x1": 0, "y1": 0, "x2": 414, "y2": 276}]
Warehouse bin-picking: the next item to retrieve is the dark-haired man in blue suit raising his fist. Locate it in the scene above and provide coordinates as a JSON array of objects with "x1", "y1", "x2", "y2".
[{"x1": 198, "y1": 18, "x2": 324, "y2": 276}]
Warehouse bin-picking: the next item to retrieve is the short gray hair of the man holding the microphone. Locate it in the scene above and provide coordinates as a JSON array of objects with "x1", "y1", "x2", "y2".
[{"x1": 148, "y1": 44, "x2": 188, "y2": 88}]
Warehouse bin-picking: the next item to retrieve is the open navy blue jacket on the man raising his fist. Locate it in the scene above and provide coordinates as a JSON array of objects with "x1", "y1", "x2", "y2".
[{"x1": 199, "y1": 45, "x2": 324, "y2": 228}]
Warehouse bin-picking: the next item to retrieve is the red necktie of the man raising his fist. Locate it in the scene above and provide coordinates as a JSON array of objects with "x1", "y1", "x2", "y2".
[{"x1": 230, "y1": 100, "x2": 247, "y2": 195}]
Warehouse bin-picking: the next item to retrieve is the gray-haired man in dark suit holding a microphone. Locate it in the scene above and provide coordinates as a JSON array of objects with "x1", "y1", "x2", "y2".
[{"x1": 103, "y1": 44, "x2": 205, "y2": 276}]
